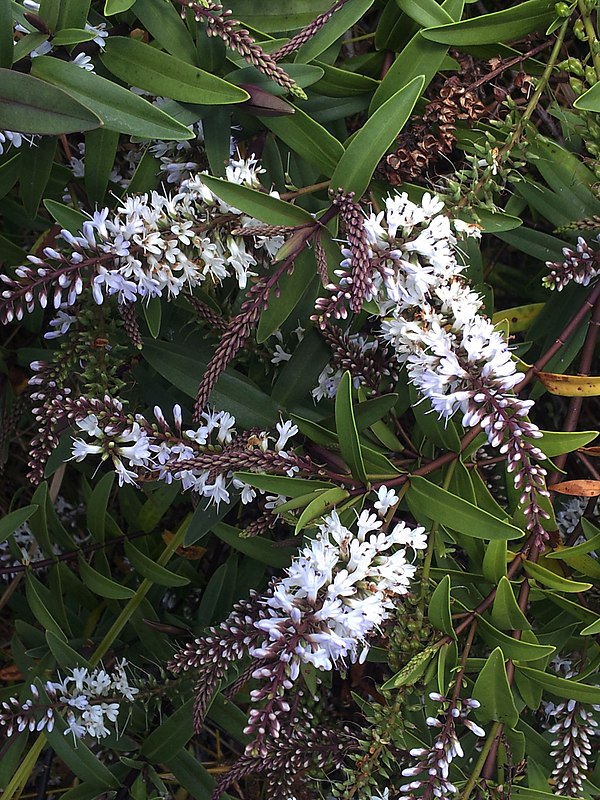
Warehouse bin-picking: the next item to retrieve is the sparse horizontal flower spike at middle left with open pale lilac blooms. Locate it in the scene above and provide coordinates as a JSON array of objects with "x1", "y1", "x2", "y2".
[{"x1": 54, "y1": 398, "x2": 300, "y2": 507}]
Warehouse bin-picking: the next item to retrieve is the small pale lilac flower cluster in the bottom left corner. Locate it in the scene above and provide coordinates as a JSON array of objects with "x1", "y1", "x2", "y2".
[{"x1": 0, "y1": 659, "x2": 140, "y2": 739}]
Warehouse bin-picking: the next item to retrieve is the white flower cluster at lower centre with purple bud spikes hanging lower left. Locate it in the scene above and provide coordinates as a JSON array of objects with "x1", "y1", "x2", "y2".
[{"x1": 171, "y1": 506, "x2": 426, "y2": 753}]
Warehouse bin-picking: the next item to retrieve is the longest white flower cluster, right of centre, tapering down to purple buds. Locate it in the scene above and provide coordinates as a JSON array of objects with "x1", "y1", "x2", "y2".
[{"x1": 318, "y1": 193, "x2": 547, "y2": 537}]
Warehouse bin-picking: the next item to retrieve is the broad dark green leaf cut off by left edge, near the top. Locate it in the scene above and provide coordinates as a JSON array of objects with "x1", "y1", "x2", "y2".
[{"x1": 0, "y1": 69, "x2": 102, "y2": 136}]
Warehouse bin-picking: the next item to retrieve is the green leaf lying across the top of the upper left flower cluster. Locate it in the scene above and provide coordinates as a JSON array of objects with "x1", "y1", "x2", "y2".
[{"x1": 202, "y1": 175, "x2": 315, "y2": 225}]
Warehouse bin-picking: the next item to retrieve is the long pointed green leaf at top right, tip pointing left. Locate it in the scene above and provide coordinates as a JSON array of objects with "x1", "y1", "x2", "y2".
[{"x1": 422, "y1": 0, "x2": 556, "y2": 47}]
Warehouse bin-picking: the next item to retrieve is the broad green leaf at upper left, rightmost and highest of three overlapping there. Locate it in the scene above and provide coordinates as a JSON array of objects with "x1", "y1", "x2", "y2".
[{"x1": 100, "y1": 36, "x2": 250, "y2": 105}]
